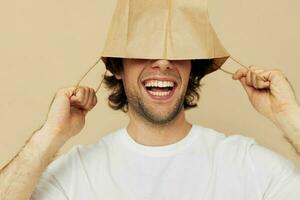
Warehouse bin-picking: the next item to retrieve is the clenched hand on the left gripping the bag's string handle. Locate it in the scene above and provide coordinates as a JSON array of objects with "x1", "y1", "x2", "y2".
[{"x1": 43, "y1": 87, "x2": 97, "y2": 139}]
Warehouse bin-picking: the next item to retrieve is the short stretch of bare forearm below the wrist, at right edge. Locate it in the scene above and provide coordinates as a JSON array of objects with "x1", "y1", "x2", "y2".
[{"x1": 273, "y1": 105, "x2": 300, "y2": 154}]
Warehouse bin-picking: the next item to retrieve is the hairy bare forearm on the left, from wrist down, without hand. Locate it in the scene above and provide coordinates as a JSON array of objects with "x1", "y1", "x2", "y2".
[{"x1": 0, "y1": 129, "x2": 66, "y2": 200}]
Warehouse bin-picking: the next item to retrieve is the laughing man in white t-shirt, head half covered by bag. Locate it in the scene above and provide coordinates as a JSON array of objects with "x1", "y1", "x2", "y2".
[{"x1": 0, "y1": 0, "x2": 300, "y2": 200}]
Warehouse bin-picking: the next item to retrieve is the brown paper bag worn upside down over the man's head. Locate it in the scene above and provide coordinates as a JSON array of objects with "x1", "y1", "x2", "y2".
[{"x1": 102, "y1": 0, "x2": 229, "y2": 73}]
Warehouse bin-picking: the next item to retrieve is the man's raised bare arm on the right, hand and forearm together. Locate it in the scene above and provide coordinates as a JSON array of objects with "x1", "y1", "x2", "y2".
[{"x1": 232, "y1": 66, "x2": 300, "y2": 154}]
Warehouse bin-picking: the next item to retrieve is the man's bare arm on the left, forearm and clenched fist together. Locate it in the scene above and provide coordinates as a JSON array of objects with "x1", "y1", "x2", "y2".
[{"x1": 0, "y1": 87, "x2": 97, "y2": 200}]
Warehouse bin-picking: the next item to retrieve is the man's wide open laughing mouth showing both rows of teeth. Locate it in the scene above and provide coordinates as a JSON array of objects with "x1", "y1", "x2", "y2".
[{"x1": 143, "y1": 80, "x2": 177, "y2": 100}]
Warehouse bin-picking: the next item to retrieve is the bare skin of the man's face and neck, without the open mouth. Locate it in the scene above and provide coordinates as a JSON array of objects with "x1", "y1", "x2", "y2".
[{"x1": 117, "y1": 59, "x2": 191, "y2": 146}]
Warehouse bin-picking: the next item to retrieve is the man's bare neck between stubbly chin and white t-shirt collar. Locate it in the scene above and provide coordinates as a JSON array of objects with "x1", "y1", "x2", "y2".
[{"x1": 127, "y1": 109, "x2": 192, "y2": 146}]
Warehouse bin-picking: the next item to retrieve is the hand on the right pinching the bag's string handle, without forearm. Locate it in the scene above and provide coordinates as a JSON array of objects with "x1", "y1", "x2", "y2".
[{"x1": 232, "y1": 66, "x2": 300, "y2": 121}]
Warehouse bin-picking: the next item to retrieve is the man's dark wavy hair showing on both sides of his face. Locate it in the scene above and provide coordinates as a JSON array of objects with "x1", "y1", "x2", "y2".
[{"x1": 104, "y1": 57, "x2": 213, "y2": 112}]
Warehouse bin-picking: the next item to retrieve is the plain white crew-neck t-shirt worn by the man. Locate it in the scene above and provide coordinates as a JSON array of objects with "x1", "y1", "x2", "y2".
[{"x1": 32, "y1": 125, "x2": 300, "y2": 200}]
